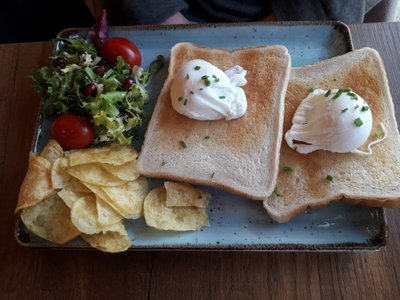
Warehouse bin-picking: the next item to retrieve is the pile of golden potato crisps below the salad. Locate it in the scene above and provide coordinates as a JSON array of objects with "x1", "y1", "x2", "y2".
[{"x1": 16, "y1": 140, "x2": 211, "y2": 253}]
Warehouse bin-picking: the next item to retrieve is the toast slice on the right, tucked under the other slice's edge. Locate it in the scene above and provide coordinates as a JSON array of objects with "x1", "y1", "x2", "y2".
[{"x1": 263, "y1": 48, "x2": 400, "y2": 222}]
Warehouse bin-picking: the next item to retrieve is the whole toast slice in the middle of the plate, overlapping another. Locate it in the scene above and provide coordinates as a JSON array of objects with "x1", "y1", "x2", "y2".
[{"x1": 138, "y1": 43, "x2": 290, "y2": 200}]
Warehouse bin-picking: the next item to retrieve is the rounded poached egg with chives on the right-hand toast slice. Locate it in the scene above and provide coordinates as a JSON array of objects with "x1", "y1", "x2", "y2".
[{"x1": 285, "y1": 89, "x2": 378, "y2": 154}]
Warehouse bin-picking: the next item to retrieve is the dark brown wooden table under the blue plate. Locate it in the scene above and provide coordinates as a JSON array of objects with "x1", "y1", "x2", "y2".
[{"x1": 0, "y1": 23, "x2": 400, "y2": 299}]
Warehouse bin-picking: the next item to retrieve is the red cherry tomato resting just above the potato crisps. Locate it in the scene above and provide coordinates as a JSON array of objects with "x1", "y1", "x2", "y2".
[{"x1": 51, "y1": 114, "x2": 94, "y2": 149}]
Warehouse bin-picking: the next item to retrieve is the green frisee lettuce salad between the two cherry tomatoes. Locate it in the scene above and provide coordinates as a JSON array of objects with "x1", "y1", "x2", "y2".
[{"x1": 31, "y1": 36, "x2": 164, "y2": 144}]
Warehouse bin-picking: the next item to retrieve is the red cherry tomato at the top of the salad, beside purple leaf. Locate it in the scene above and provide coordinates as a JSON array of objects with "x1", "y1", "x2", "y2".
[{"x1": 101, "y1": 37, "x2": 142, "y2": 68}]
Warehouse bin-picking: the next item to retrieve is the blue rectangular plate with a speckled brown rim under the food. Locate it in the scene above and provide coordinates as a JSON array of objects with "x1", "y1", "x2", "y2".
[{"x1": 16, "y1": 22, "x2": 387, "y2": 251}]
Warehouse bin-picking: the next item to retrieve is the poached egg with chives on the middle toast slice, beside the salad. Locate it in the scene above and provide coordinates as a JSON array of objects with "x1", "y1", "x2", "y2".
[{"x1": 170, "y1": 59, "x2": 247, "y2": 120}]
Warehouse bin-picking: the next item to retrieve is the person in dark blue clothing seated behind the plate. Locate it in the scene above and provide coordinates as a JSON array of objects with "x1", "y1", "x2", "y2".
[{"x1": 119, "y1": 0, "x2": 384, "y2": 24}]
